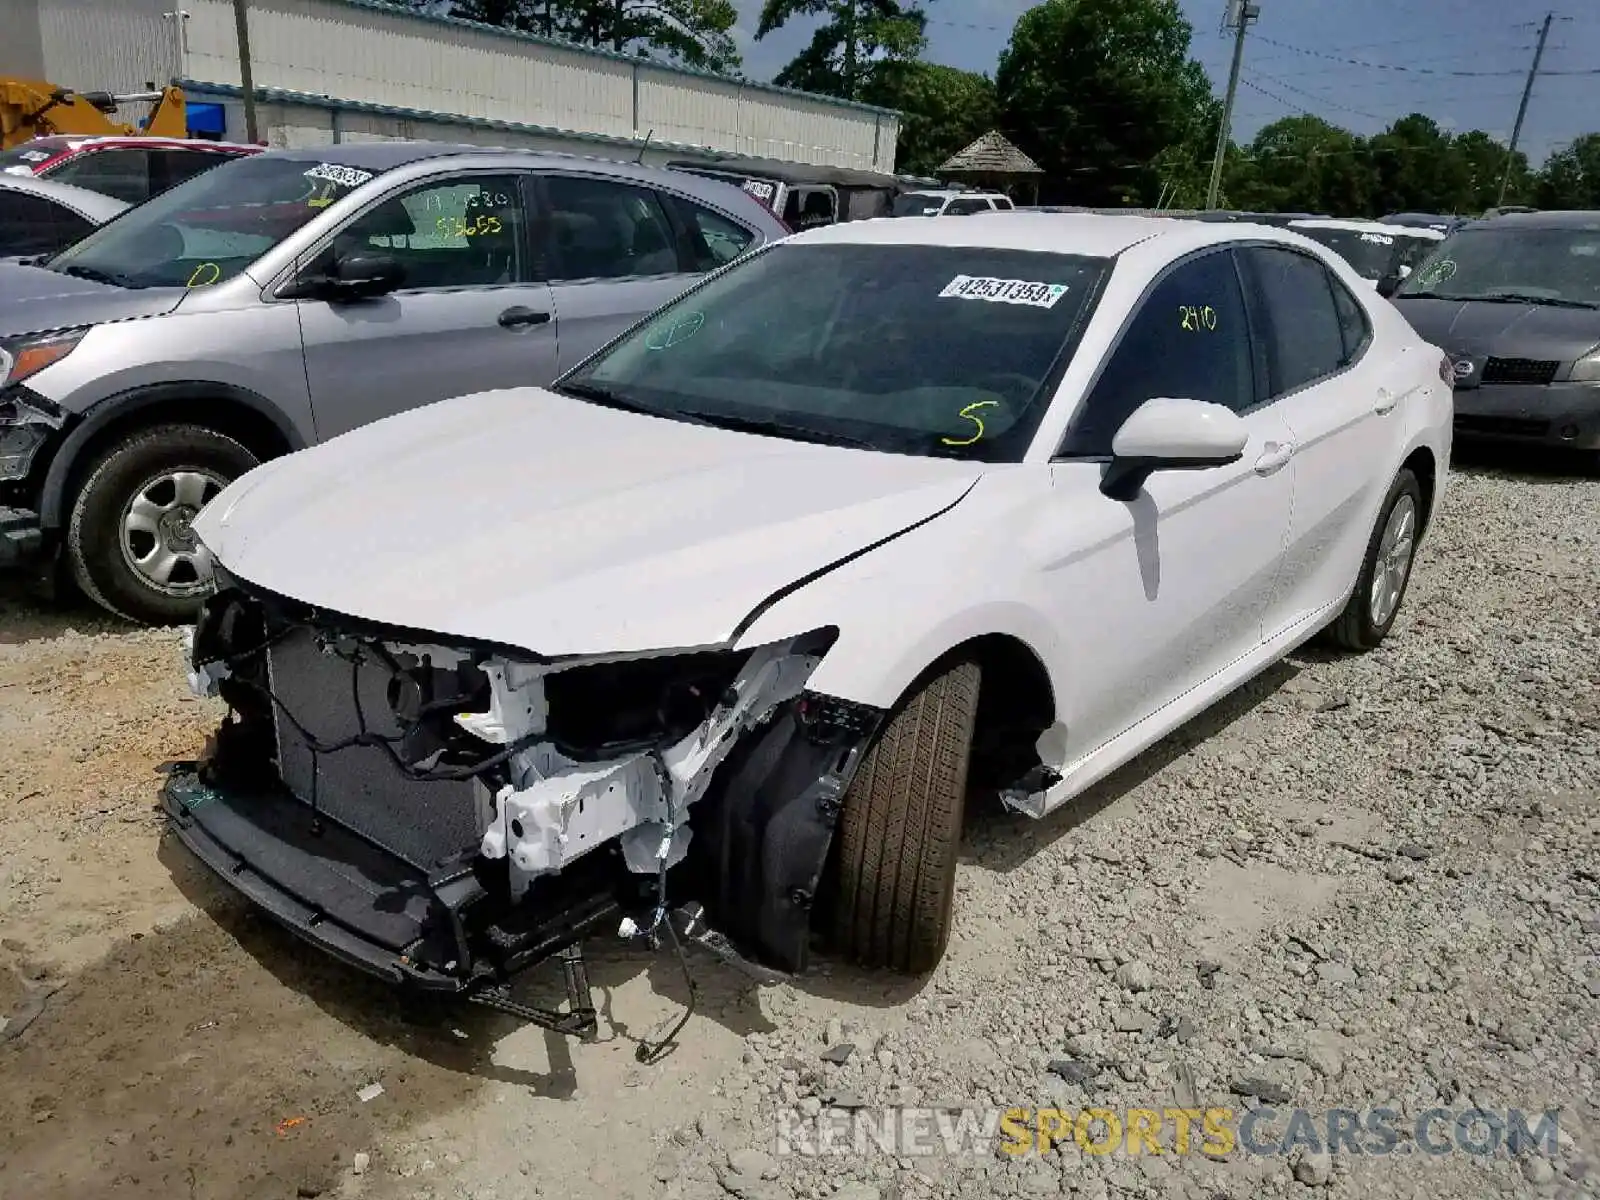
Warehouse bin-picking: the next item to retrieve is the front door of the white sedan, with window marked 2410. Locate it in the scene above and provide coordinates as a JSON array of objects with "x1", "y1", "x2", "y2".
[{"x1": 1045, "y1": 250, "x2": 1291, "y2": 762}]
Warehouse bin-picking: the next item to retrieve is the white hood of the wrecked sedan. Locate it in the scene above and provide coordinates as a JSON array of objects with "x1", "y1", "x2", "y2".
[{"x1": 195, "y1": 387, "x2": 982, "y2": 656}]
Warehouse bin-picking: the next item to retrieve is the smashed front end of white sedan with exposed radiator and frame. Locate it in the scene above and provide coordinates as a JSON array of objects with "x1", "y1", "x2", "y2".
[{"x1": 163, "y1": 571, "x2": 882, "y2": 1011}]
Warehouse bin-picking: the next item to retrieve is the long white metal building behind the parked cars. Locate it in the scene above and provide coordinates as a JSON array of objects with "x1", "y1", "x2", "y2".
[{"x1": 0, "y1": 0, "x2": 899, "y2": 173}]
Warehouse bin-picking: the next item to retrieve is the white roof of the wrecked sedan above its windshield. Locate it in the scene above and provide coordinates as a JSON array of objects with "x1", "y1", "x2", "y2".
[{"x1": 786, "y1": 211, "x2": 1306, "y2": 258}]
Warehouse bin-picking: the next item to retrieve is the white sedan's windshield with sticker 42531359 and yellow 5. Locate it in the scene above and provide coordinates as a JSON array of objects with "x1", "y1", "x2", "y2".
[{"x1": 555, "y1": 243, "x2": 1110, "y2": 462}]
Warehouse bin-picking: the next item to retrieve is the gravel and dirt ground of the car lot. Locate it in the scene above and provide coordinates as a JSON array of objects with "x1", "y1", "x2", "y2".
[{"x1": 0, "y1": 454, "x2": 1600, "y2": 1200}]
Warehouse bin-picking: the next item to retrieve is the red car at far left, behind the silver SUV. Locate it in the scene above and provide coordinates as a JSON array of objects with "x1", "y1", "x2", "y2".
[{"x1": 0, "y1": 134, "x2": 266, "y2": 205}]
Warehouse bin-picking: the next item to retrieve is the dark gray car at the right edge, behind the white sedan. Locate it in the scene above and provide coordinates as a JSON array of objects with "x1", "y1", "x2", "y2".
[{"x1": 1394, "y1": 213, "x2": 1600, "y2": 451}]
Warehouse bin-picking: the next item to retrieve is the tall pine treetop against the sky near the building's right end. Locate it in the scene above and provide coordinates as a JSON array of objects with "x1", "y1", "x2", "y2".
[{"x1": 755, "y1": 0, "x2": 928, "y2": 99}]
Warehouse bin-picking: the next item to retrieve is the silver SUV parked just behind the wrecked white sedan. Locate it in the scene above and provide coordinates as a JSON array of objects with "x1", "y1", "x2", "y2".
[{"x1": 0, "y1": 142, "x2": 787, "y2": 622}]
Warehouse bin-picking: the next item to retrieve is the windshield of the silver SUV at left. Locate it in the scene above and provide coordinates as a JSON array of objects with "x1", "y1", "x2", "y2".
[{"x1": 42, "y1": 154, "x2": 384, "y2": 288}]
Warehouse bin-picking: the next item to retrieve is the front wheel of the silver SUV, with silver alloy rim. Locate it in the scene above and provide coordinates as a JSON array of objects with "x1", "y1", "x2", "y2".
[{"x1": 66, "y1": 426, "x2": 258, "y2": 624}]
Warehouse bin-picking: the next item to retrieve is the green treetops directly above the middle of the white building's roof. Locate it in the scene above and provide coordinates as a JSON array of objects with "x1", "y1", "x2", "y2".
[{"x1": 451, "y1": 0, "x2": 739, "y2": 72}]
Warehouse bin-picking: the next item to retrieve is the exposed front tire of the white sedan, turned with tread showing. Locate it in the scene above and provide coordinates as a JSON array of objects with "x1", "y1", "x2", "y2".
[{"x1": 834, "y1": 662, "x2": 981, "y2": 974}]
